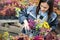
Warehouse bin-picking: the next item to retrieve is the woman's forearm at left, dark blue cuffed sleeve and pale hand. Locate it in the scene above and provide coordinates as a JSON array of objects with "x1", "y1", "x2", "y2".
[{"x1": 19, "y1": 9, "x2": 30, "y2": 30}]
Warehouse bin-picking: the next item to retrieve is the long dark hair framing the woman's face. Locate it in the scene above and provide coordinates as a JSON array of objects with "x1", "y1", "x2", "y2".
[{"x1": 36, "y1": 0, "x2": 54, "y2": 17}]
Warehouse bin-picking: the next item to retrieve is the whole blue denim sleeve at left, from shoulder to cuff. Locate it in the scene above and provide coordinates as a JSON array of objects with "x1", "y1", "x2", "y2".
[{"x1": 19, "y1": 6, "x2": 36, "y2": 23}]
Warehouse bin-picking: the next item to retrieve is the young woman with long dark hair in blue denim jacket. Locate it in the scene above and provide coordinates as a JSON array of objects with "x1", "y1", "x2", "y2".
[{"x1": 19, "y1": 0, "x2": 58, "y2": 34}]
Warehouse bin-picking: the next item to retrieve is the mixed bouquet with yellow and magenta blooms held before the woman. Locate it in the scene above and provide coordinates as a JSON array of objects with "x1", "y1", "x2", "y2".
[{"x1": 28, "y1": 19, "x2": 51, "y2": 36}]
